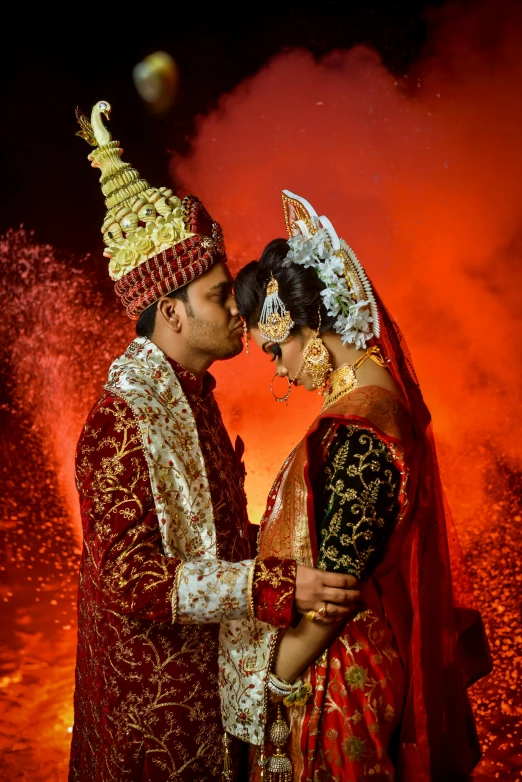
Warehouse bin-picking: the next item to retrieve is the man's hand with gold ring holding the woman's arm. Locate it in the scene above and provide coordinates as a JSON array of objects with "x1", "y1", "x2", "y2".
[{"x1": 295, "y1": 565, "x2": 361, "y2": 624}]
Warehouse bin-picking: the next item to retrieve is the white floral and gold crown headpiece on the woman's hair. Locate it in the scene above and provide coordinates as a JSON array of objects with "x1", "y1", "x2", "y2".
[{"x1": 282, "y1": 190, "x2": 380, "y2": 349}]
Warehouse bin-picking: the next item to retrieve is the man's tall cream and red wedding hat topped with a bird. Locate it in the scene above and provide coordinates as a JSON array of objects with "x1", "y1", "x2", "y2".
[{"x1": 76, "y1": 101, "x2": 227, "y2": 320}]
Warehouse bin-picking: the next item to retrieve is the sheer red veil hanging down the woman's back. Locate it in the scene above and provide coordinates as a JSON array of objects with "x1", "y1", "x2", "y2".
[{"x1": 368, "y1": 295, "x2": 492, "y2": 782}]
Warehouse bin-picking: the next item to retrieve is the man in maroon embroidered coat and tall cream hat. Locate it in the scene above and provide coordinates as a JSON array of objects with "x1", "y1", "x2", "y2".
[{"x1": 69, "y1": 101, "x2": 358, "y2": 782}]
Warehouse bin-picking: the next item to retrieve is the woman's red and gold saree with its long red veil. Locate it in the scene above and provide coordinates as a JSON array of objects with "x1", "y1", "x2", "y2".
[{"x1": 253, "y1": 302, "x2": 491, "y2": 782}]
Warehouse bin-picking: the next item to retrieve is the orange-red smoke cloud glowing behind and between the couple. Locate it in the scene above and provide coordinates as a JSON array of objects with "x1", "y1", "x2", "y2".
[{"x1": 172, "y1": 3, "x2": 522, "y2": 522}]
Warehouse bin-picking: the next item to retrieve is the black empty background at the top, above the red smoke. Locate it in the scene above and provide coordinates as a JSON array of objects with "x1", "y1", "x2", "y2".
[{"x1": 0, "y1": 0, "x2": 443, "y2": 254}]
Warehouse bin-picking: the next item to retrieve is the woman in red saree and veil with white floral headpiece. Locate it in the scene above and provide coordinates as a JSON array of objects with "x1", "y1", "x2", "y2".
[{"x1": 221, "y1": 191, "x2": 490, "y2": 782}]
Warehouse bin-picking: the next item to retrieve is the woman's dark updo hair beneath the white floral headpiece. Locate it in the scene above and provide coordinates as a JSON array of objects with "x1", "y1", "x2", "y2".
[{"x1": 234, "y1": 239, "x2": 335, "y2": 333}]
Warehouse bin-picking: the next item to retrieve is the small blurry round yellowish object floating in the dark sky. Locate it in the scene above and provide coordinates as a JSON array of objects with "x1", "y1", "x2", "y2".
[{"x1": 132, "y1": 51, "x2": 179, "y2": 111}]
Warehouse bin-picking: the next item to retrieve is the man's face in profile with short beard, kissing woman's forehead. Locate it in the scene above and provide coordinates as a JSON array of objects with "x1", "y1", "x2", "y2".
[{"x1": 182, "y1": 263, "x2": 243, "y2": 360}]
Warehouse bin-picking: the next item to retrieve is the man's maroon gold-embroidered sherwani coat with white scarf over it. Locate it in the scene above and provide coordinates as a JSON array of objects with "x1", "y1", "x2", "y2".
[{"x1": 69, "y1": 338, "x2": 295, "y2": 782}]
